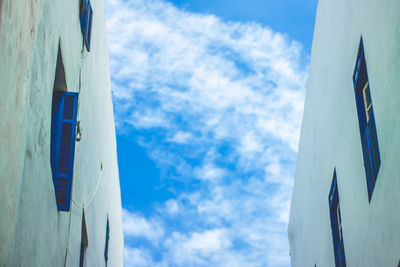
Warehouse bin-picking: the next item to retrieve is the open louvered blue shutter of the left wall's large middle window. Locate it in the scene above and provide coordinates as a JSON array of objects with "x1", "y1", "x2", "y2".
[{"x1": 53, "y1": 92, "x2": 78, "y2": 211}]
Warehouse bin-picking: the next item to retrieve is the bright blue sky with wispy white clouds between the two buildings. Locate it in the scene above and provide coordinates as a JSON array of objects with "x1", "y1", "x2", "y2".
[{"x1": 105, "y1": 0, "x2": 316, "y2": 266}]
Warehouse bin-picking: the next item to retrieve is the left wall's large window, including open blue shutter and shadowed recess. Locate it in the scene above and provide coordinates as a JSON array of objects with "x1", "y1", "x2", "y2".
[{"x1": 50, "y1": 46, "x2": 78, "y2": 214}]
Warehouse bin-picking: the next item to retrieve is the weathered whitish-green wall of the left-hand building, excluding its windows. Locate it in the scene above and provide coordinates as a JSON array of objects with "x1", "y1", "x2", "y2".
[{"x1": 0, "y1": 0, "x2": 123, "y2": 266}]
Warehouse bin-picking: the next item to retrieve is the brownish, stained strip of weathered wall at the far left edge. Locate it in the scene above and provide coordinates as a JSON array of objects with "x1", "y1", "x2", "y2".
[{"x1": 0, "y1": 0, "x2": 37, "y2": 265}]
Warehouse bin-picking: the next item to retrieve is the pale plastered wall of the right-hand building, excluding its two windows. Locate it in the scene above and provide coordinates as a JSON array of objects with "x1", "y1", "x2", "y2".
[{"x1": 288, "y1": 0, "x2": 400, "y2": 267}]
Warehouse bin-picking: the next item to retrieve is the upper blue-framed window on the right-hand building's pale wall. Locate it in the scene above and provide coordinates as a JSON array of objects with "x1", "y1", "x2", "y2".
[{"x1": 353, "y1": 38, "x2": 381, "y2": 201}]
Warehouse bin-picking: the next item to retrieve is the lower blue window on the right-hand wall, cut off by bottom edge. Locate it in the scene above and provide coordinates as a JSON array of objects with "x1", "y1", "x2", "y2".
[{"x1": 329, "y1": 169, "x2": 346, "y2": 267}]
